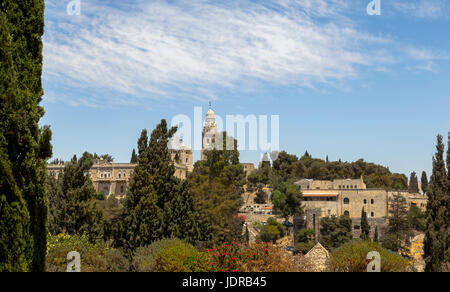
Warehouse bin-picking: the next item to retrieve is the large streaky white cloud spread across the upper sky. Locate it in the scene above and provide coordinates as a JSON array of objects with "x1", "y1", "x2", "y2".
[{"x1": 44, "y1": 0, "x2": 446, "y2": 104}]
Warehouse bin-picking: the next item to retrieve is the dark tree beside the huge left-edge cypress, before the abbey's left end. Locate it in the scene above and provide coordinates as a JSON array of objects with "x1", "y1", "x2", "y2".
[{"x1": 47, "y1": 152, "x2": 103, "y2": 241}]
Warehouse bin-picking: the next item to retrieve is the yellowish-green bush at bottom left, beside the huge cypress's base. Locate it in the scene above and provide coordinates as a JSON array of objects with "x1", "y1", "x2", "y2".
[{"x1": 46, "y1": 234, "x2": 129, "y2": 272}]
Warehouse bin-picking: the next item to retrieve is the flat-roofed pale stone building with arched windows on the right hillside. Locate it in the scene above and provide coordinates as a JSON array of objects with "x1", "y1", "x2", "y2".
[{"x1": 295, "y1": 178, "x2": 427, "y2": 241}]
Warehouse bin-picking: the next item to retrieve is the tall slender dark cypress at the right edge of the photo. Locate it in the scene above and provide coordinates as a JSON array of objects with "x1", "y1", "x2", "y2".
[{"x1": 424, "y1": 135, "x2": 450, "y2": 272}]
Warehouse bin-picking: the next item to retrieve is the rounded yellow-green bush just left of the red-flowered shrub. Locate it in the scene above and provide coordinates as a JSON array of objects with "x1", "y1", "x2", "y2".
[{"x1": 133, "y1": 239, "x2": 199, "y2": 272}]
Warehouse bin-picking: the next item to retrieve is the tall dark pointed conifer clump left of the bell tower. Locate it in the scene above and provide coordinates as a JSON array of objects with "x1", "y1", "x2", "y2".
[{"x1": 115, "y1": 120, "x2": 210, "y2": 257}]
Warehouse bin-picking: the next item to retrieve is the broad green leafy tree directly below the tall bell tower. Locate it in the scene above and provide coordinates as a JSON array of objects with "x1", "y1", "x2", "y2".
[{"x1": 188, "y1": 132, "x2": 245, "y2": 243}]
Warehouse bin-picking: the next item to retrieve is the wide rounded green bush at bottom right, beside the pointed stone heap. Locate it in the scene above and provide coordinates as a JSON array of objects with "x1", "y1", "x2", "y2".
[{"x1": 328, "y1": 240, "x2": 409, "y2": 272}]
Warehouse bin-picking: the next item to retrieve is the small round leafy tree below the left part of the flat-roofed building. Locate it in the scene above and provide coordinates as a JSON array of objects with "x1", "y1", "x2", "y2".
[{"x1": 320, "y1": 215, "x2": 353, "y2": 249}]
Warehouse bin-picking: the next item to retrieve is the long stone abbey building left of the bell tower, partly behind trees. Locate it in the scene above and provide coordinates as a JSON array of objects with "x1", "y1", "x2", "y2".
[{"x1": 47, "y1": 144, "x2": 192, "y2": 198}]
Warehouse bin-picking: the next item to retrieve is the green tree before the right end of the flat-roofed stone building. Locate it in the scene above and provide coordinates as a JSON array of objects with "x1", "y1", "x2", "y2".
[{"x1": 383, "y1": 193, "x2": 411, "y2": 251}]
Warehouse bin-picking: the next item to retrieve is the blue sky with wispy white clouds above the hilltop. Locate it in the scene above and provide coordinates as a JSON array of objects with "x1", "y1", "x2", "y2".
[{"x1": 41, "y1": 0, "x2": 450, "y2": 174}]
